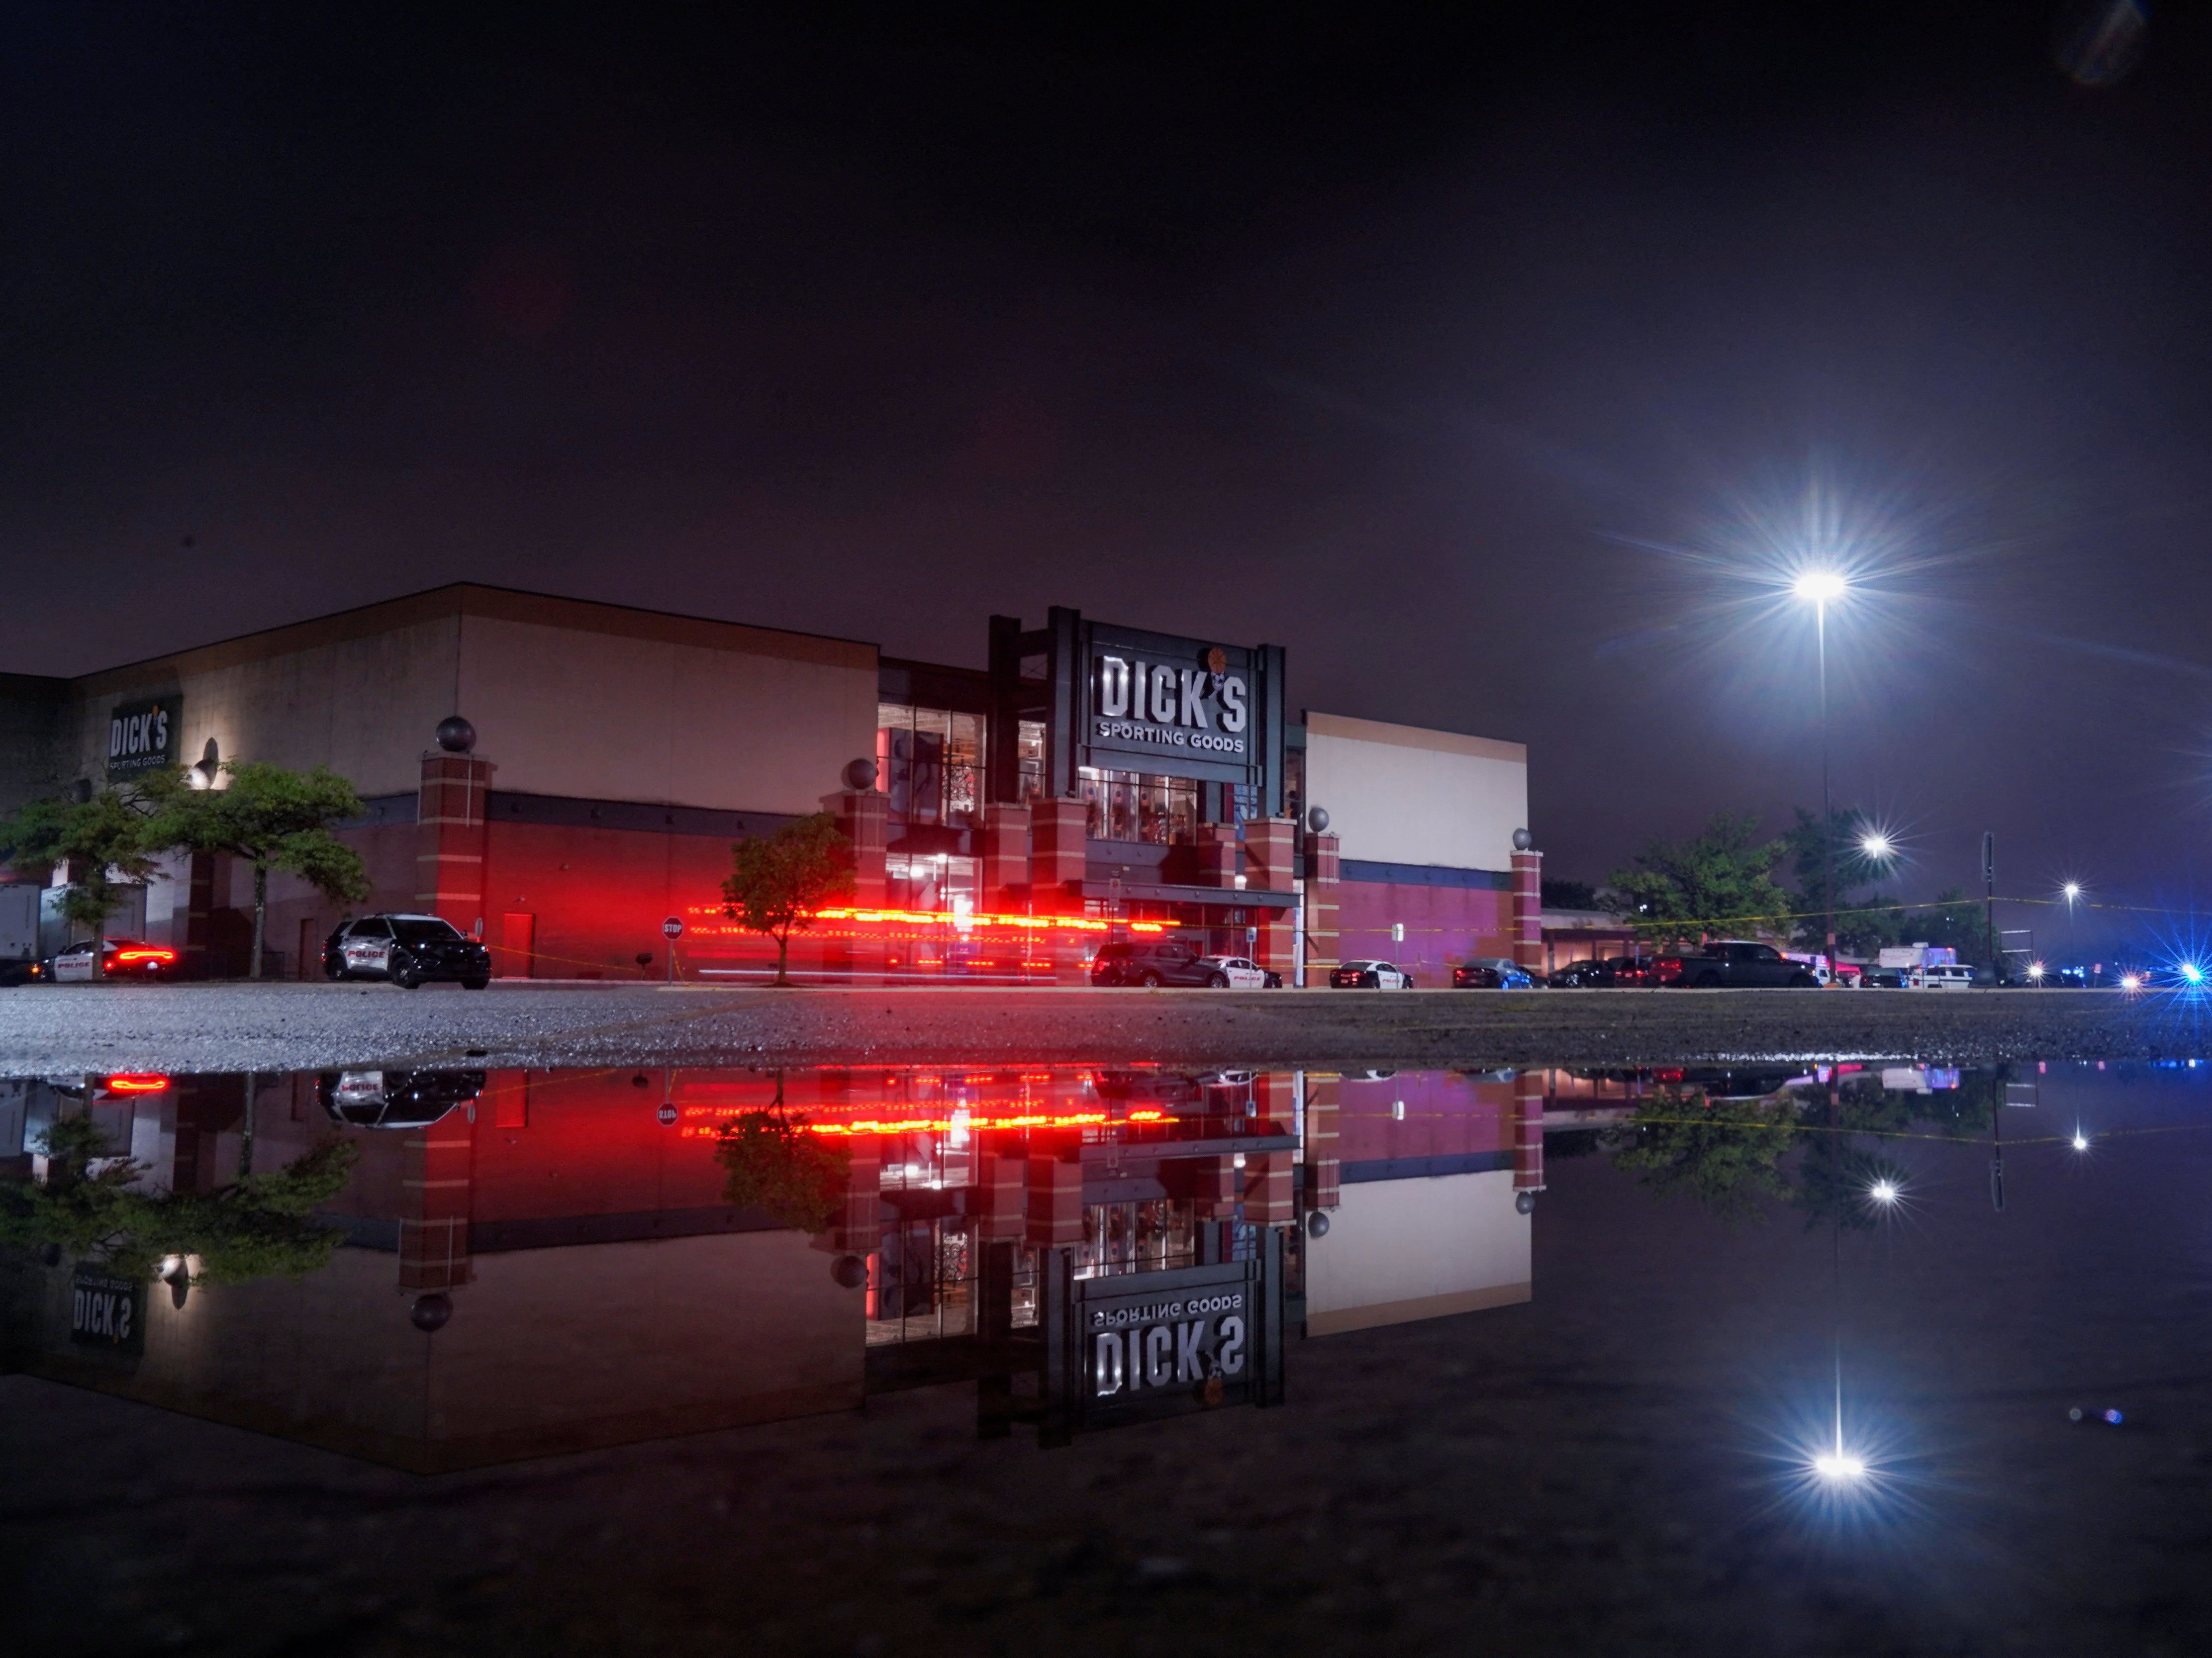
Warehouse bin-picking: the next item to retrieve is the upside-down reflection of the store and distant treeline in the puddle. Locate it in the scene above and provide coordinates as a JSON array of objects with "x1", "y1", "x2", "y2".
[{"x1": 0, "y1": 1066, "x2": 2194, "y2": 1476}]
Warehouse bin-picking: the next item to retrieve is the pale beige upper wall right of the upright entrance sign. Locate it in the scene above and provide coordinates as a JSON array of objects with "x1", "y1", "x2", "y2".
[{"x1": 1305, "y1": 712, "x2": 1529, "y2": 869}]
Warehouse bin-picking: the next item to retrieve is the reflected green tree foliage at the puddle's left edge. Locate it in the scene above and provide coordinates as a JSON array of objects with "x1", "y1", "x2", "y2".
[{"x1": 0, "y1": 1116, "x2": 356, "y2": 1285}]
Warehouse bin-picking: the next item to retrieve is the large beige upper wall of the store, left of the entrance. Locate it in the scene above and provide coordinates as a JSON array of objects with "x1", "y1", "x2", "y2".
[{"x1": 60, "y1": 586, "x2": 876, "y2": 811}]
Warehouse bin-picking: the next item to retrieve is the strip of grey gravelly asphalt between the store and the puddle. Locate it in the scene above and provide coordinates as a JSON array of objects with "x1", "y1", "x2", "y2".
[{"x1": 0, "y1": 984, "x2": 2212, "y2": 1077}]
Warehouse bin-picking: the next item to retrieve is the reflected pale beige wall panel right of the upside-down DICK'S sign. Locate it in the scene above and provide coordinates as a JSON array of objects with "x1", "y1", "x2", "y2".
[{"x1": 1305, "y1": 1170, "x2": 1533, "y2": 1335}]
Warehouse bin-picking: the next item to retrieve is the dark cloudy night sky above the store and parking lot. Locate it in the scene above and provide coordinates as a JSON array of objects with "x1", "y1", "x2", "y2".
[{"x1": 0, "y1": 2, "x2": 2212, "y2": 946}]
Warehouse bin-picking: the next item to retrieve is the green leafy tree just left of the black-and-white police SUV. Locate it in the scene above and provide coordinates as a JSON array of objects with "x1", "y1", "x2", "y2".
[{"x1": 146, "y1": 760, "x2": 370, "y2": 979}]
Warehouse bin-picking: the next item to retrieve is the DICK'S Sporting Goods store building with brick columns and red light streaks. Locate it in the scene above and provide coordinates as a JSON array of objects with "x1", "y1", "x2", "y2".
[{"x1": 0, "y1": 584, "x2": 1542, "y2": 984}]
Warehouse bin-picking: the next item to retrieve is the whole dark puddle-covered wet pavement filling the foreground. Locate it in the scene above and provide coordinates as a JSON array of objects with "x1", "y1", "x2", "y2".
[{"x1": 0, "y1": 1061, "x2": 2212, "y2": 1654}]
